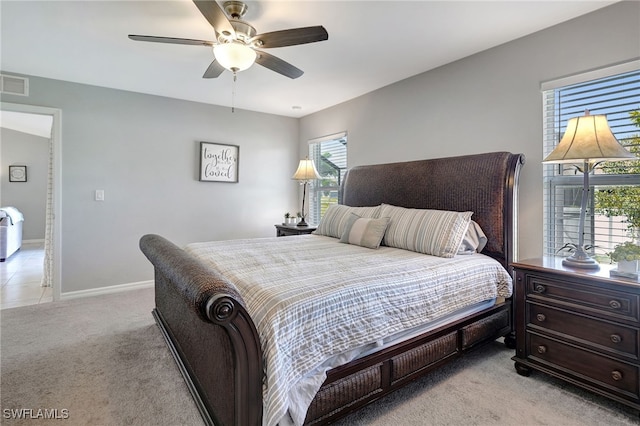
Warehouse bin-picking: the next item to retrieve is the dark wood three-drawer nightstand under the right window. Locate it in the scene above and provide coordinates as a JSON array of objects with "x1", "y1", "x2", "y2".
[{"x1": 513, "y1": 258, "x2": 640, "y2": 410}]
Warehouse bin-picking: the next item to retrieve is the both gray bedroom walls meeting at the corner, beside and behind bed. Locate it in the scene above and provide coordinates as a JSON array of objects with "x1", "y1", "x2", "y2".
[{"x1": 2, "y1": 2, "x2": 640, "y2": 293}]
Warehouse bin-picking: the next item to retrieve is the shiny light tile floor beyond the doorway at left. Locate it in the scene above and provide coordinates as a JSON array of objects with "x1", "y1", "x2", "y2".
[{"x1": 0, "y1": 243, "x2": 53, "y2": 309}]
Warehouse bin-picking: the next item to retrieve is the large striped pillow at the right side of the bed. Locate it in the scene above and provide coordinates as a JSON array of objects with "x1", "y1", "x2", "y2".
[{"x1": 380, "y1": 204, "x2": 473, "y2": 257}]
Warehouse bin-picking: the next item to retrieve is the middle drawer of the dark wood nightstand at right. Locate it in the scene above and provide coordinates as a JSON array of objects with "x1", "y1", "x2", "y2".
[{"x1": 527, "y1": 303, "x2": 638, "y2": 360}]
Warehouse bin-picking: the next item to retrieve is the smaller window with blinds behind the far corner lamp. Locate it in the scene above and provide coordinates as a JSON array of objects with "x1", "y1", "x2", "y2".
[{"x1": 307, "y1": 132, "x2": 347, "y2": 224}]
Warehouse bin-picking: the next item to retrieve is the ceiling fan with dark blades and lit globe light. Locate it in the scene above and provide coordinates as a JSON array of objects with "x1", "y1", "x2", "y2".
[{"x1": 129, "y1": 0, "x2": 329, "y2": 78}]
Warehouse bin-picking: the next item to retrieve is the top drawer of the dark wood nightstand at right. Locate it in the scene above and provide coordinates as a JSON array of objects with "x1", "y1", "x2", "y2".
[{"x1": 526, "y1": 276, "x2": 640, "y2": 323}]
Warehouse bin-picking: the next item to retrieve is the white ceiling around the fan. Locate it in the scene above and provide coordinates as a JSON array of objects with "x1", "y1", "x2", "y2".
[{"x1": 0, "y1": 0, "x2": 615, "y2": 117}]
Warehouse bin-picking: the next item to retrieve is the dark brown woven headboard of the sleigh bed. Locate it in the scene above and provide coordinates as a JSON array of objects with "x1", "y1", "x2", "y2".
[{"x1": 340, "y1": 152, "x2": 524, "y2": 270}]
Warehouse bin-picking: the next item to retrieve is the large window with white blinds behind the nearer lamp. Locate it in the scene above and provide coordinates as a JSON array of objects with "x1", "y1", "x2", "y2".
[{"x1": 542, "y1": 61, "x2": 640, "y2": 261}]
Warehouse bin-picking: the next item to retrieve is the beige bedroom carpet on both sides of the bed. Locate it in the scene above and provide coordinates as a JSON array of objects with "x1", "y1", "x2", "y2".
[{"x1": 0, "y1": 290, "x2": 639, "y2": 426}]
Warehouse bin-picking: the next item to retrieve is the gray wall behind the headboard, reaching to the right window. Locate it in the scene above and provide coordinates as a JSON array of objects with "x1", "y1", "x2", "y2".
[{"x1": 300, "y1": 2, "x2": 640, "y2": 258}]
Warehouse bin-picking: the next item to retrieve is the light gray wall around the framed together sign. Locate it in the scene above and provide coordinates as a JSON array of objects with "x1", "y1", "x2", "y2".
[{"x1": 2, "y1": 76, "x2": 299, "y2": 293}]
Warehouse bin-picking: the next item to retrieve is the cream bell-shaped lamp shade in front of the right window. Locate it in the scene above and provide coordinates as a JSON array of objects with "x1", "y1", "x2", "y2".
[{"x1": 543, "y1": 111, "x2": 636, "y2": 164}]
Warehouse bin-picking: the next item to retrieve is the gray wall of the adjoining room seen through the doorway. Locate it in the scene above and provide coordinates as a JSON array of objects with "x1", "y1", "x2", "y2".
[{"x1": 0, "y1": 128, "x2": 49, "y2": 240}]
